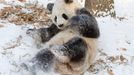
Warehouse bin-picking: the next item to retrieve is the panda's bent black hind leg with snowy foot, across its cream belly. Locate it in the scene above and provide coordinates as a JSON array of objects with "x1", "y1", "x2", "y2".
[{"x1": 51, "y1": 37, "x2": 87, "y2": 62}]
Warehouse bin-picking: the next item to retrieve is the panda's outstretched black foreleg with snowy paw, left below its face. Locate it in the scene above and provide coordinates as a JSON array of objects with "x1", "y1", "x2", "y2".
[{"x1": 26, "y1": 24, "x2": 60, "y2": 43}]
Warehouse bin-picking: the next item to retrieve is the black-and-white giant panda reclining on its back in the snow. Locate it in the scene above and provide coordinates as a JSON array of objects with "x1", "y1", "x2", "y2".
[{"x1": 25, "y1": 0, "x2": 100, "y2": 75}]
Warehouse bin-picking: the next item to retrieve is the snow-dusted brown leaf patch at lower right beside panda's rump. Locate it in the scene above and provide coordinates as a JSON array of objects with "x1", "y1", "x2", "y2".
[{"x1": 89, "y1": 51, "x2": 128, "y2": 75}]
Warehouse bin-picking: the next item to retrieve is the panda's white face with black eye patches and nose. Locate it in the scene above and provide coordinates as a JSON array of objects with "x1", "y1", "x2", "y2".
[{"x1": 51, "y1": 0, "x2": 83, "y2": 29}]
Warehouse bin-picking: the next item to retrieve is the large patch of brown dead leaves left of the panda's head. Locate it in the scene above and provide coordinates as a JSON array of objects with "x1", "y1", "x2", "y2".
[{"x1": 0, "y1": 4, "x2": 52, "y2": 28}]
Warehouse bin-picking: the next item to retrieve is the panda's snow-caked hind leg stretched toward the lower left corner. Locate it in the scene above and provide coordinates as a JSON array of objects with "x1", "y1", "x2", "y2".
[{"x1": 21, "y1": 49, "x2": 55, "y2": 75}]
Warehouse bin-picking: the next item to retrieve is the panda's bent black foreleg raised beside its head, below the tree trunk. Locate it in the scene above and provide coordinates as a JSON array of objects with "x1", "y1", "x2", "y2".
[{"x1": 69, "y1": 11, "x2": 100, "y2": 38}]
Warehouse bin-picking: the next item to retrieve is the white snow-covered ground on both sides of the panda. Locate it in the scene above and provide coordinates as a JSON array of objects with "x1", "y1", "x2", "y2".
[{"x1": 0, "y1": 0, "x2": 134, "y2": 75}]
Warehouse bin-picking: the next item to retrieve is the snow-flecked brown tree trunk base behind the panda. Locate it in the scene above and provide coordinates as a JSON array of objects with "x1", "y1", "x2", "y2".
[{"x1": 85, "y1": 0, "x2": 116, "y2": 17}]
